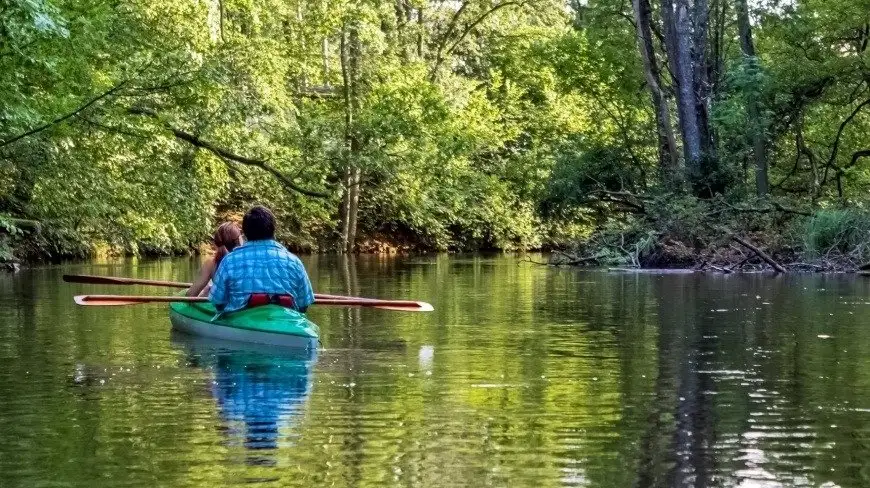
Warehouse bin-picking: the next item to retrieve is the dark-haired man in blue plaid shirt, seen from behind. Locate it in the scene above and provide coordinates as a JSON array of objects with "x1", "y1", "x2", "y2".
[{"x1": 208, "y1": 206, "x2": 314, "y2": 312}]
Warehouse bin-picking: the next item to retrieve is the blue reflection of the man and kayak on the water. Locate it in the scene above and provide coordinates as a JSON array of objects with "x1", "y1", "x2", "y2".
[{"x1": 171, "y1": 332, "x2": 317, "y2": 450}]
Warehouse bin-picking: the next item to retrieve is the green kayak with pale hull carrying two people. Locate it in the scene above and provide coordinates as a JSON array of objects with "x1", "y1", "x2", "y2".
[{"x1": 169, "y1": 302, "x2": 320, "y2": 349}]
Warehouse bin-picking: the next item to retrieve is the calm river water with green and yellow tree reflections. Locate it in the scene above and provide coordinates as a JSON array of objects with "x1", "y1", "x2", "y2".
[{"x1": 0, "y1": 256, "x2": 870, "y2": 488}]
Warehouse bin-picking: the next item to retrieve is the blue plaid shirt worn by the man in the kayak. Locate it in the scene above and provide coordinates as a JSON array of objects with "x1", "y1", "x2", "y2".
[{"x1": 208, "y1": 239, "x2": 314, "y2": 312}]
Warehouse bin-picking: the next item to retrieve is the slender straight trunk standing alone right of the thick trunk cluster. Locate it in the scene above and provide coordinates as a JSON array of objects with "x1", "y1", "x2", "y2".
[{"x1": 737, "y1": 0, "x2": 769, "y2": 198}]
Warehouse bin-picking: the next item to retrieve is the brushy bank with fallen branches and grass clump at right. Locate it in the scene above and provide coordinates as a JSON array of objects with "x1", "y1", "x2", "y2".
[{"x1": 546, "y1": 200, "x2": 870, "y2": 273}]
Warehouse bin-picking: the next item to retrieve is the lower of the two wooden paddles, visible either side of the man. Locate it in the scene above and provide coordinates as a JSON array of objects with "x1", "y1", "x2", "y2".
[{"x1": 75, "y1": 295, "x2": 434, "y2": 312}]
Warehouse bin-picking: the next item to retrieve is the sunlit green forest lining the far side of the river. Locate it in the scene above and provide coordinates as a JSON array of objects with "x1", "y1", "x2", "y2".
[{"x1": 0, "y1": 0, "x2": 870, "y2": 271}]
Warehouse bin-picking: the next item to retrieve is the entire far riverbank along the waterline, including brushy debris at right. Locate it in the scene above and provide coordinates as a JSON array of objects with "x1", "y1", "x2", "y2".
[{"x1": 6, "y1": 195, "x2": 870, "y2": 273}]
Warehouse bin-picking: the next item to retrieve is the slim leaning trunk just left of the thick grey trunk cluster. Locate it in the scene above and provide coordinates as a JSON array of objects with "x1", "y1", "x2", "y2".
[{"x1": 631, "y1": 0, "x2": 679, "y2": 186}]
